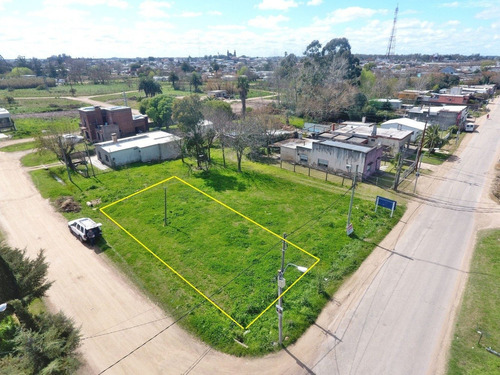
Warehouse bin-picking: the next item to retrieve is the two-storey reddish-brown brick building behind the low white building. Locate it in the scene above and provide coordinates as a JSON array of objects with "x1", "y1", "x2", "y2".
[{"x1": 78, "y1": 106, "x2": 149, "y2": 142}]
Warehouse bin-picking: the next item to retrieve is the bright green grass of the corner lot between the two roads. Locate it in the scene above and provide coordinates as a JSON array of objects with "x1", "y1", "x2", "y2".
[{"x1": 32, "y1": 151, "x2": 404, "y2": 355}]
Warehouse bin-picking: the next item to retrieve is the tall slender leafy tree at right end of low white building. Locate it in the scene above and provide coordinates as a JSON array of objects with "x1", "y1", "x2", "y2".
[{"x1": 172, "y1": 95, "x2": 205, "y2": 168}]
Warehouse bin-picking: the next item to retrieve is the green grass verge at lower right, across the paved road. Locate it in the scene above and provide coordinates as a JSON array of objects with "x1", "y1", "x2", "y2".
[{"x1": 447, "y1": 229, "x2": 500, "y2": 375}]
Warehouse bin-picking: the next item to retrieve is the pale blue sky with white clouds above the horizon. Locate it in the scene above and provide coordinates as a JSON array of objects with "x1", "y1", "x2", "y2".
[{"x1": 0, "y1": 0, "x2": 500, "y2": 59}]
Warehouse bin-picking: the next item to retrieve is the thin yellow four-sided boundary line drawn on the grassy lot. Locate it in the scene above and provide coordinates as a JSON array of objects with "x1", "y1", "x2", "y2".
[{"x1": 99, "y1": 176, "x2": 320, "y2": 329}]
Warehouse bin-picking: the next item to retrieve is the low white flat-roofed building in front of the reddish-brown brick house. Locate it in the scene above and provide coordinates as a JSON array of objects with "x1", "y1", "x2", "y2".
[{"x1": 95, "y1": 131, "x2": 181, "y2": 168}]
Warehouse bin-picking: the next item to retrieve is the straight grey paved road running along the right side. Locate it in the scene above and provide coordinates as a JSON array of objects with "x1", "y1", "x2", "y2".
[{"x1": 312, "y1": 100, "x2": 500, "y2": 375}]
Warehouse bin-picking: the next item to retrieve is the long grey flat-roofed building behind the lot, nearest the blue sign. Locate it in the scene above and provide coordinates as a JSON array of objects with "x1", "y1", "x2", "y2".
[{"x1": 276, "y1": 138, "x2": 382, "y2": 178}]
